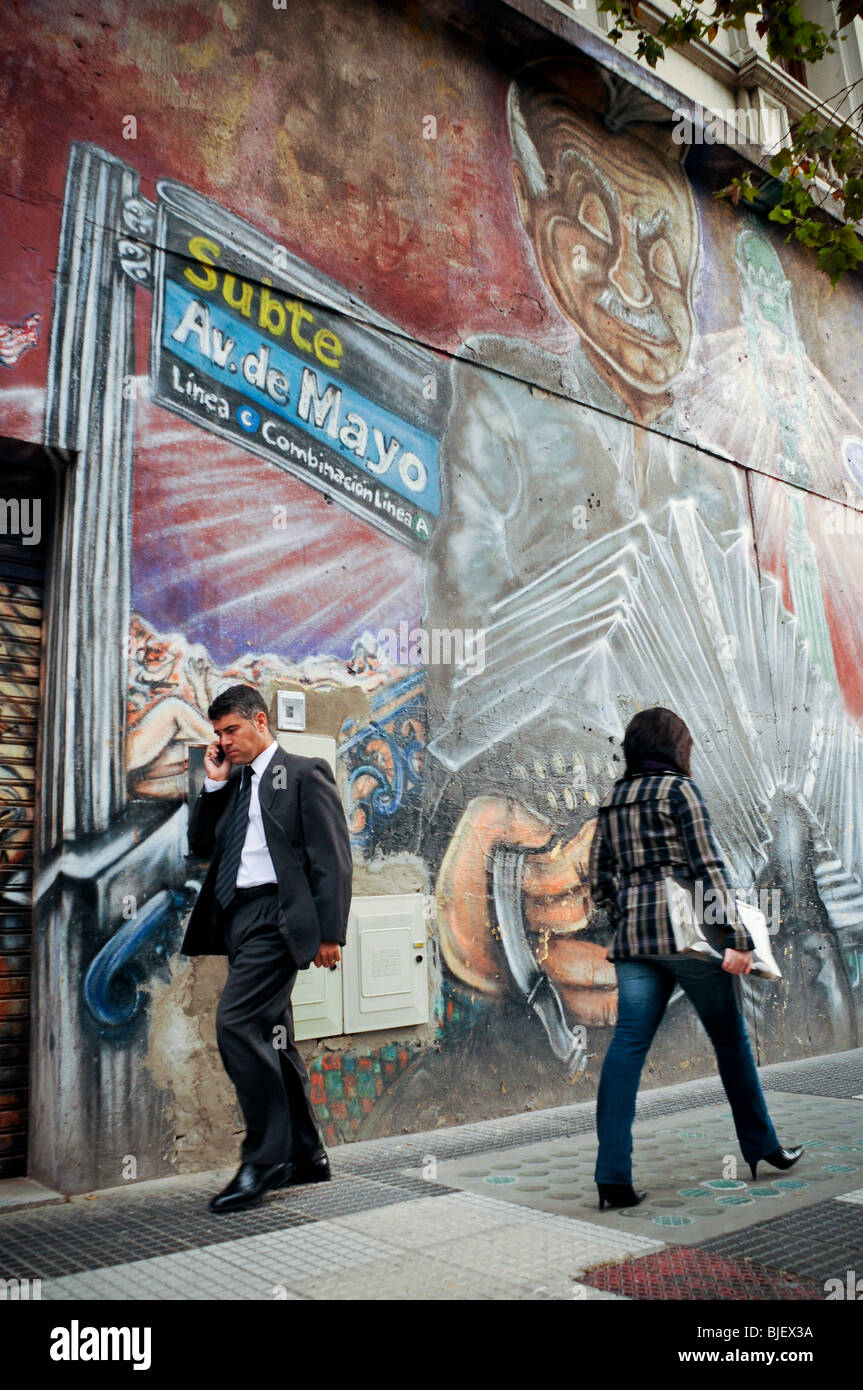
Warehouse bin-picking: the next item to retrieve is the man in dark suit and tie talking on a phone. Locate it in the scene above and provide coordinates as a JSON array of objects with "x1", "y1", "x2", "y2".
[{"x1": 181, "y1": 685, "x2": 352, "y2": 1212}]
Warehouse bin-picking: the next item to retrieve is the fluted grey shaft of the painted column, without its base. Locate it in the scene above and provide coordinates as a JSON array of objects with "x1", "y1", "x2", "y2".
[{"x1": 40, "y1": 145, "x2": 139, "y2": 855}]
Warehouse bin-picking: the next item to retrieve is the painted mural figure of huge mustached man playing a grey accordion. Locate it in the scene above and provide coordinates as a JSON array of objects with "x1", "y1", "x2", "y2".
[{"x1": 411, "y1": 63, "x2": 863, "y2": 1128}]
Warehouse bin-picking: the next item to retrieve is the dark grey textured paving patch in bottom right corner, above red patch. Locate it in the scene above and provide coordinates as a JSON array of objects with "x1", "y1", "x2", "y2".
[{"x1": 699, "y1": 1201, "x2": 863, "y2": 1298}]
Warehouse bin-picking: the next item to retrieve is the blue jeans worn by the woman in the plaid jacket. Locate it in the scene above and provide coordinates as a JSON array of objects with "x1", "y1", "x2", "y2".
[{"x1": 593, "y1": 959, "x2": 780, "y2": 1183}]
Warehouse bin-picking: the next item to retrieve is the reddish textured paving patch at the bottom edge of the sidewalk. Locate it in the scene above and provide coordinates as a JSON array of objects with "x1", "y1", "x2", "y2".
[{"x1": 582, "y1": 1245, "x2": 824, "y2": 1302}]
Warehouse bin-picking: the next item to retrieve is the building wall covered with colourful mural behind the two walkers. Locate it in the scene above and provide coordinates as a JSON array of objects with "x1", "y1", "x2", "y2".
[{"x1": 0, "y1": 0, "x2": 863, "y2": 1193}]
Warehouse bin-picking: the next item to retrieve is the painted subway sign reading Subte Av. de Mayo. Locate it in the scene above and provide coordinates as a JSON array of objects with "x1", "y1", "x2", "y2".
[{"x1": 151, "y1": 185, "x2": 445, "y2": 549}]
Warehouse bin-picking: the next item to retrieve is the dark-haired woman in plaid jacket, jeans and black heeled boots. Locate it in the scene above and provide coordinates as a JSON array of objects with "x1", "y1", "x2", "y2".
[{"x1": 591, "y1": 708, "x2": 803, "y2": 1211}]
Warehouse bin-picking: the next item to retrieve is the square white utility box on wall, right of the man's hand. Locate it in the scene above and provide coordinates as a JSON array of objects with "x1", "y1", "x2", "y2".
[{"x1": 342, "y1": 892, "x2": 428, "y2": 1033}]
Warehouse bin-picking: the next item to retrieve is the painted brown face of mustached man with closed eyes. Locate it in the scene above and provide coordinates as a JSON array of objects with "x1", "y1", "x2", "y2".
[{"x1": 514, "y1": 113, "x2": 698, "y2": 395}]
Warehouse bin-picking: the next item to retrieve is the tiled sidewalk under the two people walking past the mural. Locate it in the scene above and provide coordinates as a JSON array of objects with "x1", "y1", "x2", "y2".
[{"x1": 0, "y1": 1048, "x2": 863, "y2": 1301}]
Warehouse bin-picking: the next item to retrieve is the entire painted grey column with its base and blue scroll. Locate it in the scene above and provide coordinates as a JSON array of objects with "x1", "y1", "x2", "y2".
[{"x1": 29, "y1": 145, "x2": 185, "y2": 1193}]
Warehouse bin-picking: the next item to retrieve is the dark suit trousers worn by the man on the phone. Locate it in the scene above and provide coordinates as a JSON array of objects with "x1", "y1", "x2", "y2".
[{"x1": 215, "y1": 888, "x2": 324, "y2": 1165}]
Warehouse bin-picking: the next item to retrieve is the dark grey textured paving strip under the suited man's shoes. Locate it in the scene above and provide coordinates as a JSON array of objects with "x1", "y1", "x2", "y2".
[{"x1": 0, "y1": 1175, "x2": 436, "y2": 1279}]
